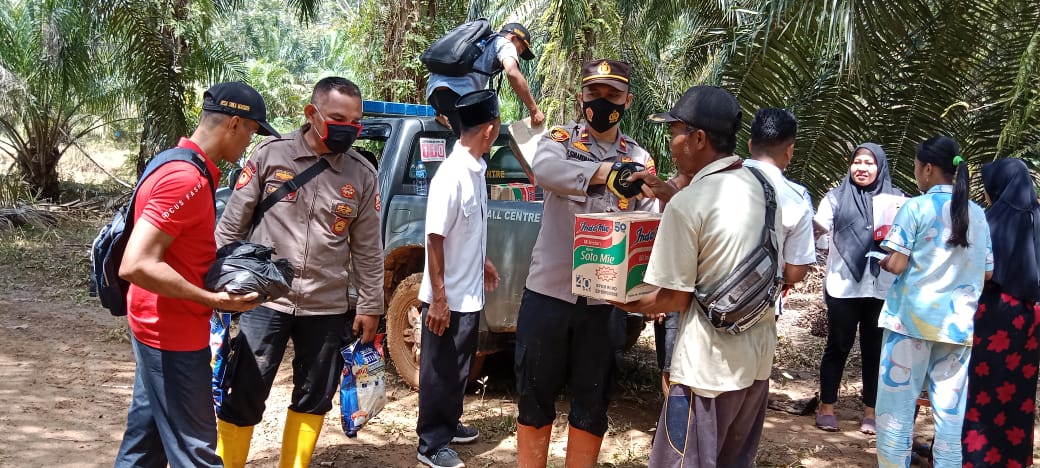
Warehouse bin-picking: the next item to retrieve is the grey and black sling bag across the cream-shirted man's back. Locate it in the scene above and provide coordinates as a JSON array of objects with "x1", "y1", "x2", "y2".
[{"x1": 694, "y1": 167, "x2": 783, "y2": 335}]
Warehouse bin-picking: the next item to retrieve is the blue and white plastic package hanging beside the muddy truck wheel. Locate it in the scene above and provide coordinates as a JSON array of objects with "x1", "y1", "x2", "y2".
[{"x1": 339, "y1": 334, "x2": 387, "y2": 437}]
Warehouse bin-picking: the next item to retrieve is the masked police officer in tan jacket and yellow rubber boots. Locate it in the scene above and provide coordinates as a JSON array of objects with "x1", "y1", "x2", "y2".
[{"x1": 216, "y1": 77, "x2": 383, "y2": 467}]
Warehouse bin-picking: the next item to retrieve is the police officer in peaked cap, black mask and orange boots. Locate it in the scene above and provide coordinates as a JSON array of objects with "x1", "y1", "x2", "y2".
[{"x1": 515, "y1": 60, "x2": 655, "y2": 468}]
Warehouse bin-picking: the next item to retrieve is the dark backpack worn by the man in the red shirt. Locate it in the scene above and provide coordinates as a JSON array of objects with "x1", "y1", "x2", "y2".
[{"x1": 88, "y1": 148, "x2": 216, "y2": 317}]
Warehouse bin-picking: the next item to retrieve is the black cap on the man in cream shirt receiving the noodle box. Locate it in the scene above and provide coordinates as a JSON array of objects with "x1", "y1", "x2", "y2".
[{"x1": 648, "y1": 85, "x2": 740, "y2": 134}]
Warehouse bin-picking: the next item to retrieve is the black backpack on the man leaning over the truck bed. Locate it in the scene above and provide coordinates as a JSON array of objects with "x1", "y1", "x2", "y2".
[{"x1": 419, "y1": 18, "x2": 498, "y2": 76}]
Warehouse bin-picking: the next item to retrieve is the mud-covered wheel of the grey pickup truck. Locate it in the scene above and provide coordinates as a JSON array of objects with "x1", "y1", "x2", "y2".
[{"x1": 387, "y1": 272, "x2": 422, "y2": 388}]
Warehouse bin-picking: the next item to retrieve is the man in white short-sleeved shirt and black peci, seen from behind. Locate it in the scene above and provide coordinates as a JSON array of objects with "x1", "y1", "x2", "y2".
[{"x1": 415, "y1": 89, "x2": 501, "y2": 468}]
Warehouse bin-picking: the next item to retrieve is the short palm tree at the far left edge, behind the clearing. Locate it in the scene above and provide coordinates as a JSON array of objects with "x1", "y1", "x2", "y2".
[{"x1": 0, "y1": 0, "x2": 119, "y2": 199}]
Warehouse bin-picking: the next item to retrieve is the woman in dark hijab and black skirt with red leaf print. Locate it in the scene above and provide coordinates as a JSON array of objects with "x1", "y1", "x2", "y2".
[{"x1": 962, "y1": 158, "x2": 1040, "y2": 467}]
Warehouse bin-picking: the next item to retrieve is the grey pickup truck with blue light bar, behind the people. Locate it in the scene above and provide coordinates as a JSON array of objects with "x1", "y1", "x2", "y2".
[{"x1": 217, "y1": 101, "x2": 645, "y2": 388}]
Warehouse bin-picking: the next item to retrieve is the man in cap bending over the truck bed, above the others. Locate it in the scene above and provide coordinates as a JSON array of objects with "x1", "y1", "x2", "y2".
[{"x1": 426, "y1": 23, "x2": 545, "y2": 136}]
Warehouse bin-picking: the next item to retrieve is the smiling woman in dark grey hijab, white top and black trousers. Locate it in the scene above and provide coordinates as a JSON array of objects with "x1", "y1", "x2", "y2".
[{"x1": 814, "y1": 142, "x2": 902, "y2": 434}]
